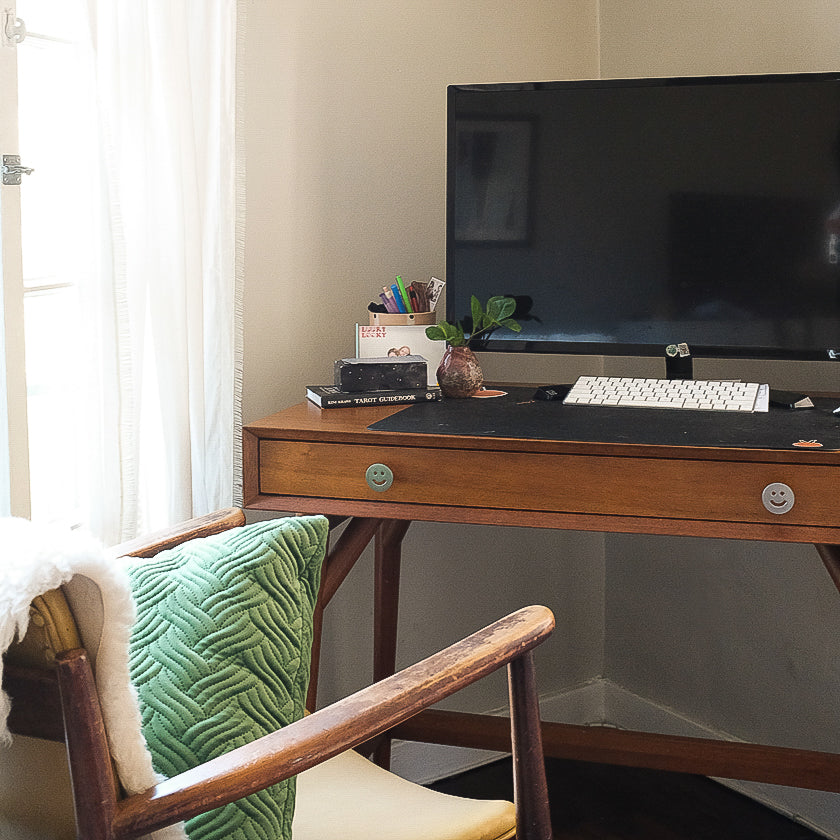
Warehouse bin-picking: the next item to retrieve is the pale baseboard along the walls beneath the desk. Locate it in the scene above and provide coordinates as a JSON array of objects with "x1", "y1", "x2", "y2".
[{"x1": 392, "y1": 679, "x2": 840, "y2": 840}]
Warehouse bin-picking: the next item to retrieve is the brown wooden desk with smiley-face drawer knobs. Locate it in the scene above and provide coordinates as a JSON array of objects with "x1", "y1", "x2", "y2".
[{"x1": 244, "y1": 403, "x2": 840, "y2": 792}]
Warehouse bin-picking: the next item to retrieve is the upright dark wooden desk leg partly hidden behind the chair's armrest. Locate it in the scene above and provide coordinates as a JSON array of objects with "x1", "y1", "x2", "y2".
[{"x1": 373, "y1": 519, "x2": 411, "y2": 768}]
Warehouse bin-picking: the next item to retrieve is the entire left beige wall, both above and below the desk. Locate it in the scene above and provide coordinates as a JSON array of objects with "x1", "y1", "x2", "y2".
[{"x1": 243, "y1": 0, "x2": 603, "y2": 708}]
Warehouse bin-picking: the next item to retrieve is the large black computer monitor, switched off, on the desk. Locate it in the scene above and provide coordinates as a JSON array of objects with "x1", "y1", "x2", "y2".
[{"x1": 446, "y1": 73, "x2": 840, "y2": 359}]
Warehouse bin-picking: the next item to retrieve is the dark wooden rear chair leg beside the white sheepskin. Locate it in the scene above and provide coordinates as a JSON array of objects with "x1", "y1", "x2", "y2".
[{"x1": 56, "y1": 649, "x2": 117, "y2": 840}]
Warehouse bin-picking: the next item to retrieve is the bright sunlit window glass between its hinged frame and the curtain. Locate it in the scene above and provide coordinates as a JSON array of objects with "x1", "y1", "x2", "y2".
[{"x1": 17, "y1": 8, "x2": 99, "y2": 525}]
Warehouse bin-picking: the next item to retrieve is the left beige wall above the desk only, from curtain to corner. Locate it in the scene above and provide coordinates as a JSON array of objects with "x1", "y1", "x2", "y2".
[{"x1": 244, "y1": 0, "x2": 597, "y2": 420}]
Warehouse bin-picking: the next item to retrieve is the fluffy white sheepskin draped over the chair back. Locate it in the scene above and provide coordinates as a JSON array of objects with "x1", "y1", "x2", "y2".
[{"x1": 0, "y1": 518, "x2": 186, "y2": 840}]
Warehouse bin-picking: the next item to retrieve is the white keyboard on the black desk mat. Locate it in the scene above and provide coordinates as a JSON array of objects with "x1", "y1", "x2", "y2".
[{"x1": 563, "y1": 376, "x2": 770, "y2": 411}]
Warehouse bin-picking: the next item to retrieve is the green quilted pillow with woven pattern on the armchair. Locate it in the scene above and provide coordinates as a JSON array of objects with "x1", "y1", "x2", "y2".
[{"x1": 129, "y1": 516, "x2": 329, "y2": 840}]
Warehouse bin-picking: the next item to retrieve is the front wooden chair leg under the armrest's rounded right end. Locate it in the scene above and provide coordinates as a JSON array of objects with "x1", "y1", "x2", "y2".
[{"x1": 508, "y1": 651, "x2": 552, "y2": 840}]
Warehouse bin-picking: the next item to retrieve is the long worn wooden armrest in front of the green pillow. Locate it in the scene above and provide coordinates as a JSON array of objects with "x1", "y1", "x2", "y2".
[{"x1": 114, "y1": 606, "x2": 554, "y2": 838}]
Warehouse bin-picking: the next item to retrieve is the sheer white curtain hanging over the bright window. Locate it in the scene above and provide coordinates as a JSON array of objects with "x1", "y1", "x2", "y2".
[{"x1": 84, "y1": 0, "x2": 242, "y2": 544}]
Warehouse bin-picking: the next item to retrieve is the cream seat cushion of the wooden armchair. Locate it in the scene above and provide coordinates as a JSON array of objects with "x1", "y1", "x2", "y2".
[{"x1": 292, "y1": 750, "x2": 516, "y2": 840}]
